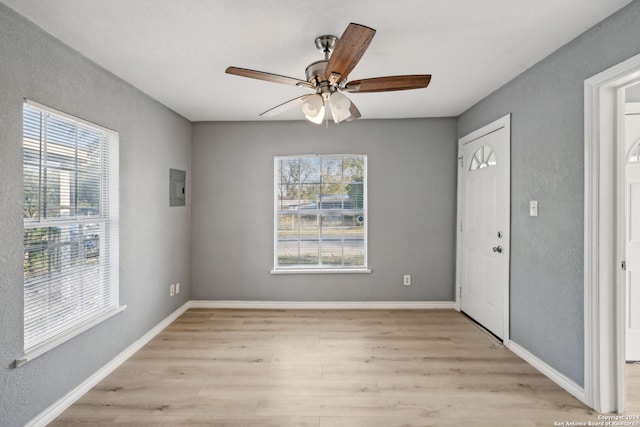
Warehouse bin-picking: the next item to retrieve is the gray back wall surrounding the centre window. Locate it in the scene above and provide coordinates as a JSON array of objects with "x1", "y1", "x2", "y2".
[{"x1": 191, "y1": 118, "x2": 457, "y2": 301}]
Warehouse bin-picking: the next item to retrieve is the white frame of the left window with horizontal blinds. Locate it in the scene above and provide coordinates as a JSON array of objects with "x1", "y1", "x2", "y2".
[{"x1": 15, "y1": 99, "x2": 126, "y2": 367}]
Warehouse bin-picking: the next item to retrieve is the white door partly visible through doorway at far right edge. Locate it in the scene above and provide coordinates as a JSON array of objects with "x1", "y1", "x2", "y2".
[{"x1": 625, "y1": 137, "x2": 640, "y2": 361}]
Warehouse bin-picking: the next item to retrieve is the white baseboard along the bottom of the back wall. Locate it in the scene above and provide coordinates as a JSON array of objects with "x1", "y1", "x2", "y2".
[{"x1": 190, "y1": 301, "x2": 455, "y2": 310}]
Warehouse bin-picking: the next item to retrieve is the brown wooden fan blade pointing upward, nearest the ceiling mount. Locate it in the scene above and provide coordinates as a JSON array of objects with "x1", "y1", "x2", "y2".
[{"x1": 324, "y1": 23, "x2": 376, "y2": 83}]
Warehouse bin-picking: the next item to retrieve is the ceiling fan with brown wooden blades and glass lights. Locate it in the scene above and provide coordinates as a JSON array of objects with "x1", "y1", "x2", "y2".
[{"x1": 226, "y1": 23, "x2": 431, "y2": 124}]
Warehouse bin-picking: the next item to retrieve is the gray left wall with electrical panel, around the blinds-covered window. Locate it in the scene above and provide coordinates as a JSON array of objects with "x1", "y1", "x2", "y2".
[{"x1": 0, "y1": 4, "x2": 191, "y2": 427}]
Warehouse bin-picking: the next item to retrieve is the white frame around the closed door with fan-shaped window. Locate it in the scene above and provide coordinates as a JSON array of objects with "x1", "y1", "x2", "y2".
[{"x1": 454, "y1": 114, "x2": 511, "y2": 346}]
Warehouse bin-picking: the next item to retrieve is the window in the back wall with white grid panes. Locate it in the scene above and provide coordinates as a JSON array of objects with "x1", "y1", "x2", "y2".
[{"x1": 274, "y1": 155, "x2": 367, "y2": 272}]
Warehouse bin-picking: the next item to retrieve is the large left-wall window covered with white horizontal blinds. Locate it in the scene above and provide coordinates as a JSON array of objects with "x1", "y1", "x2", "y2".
[{"x1": 18, "y1": 101, "x2": 120, "y2": 364}]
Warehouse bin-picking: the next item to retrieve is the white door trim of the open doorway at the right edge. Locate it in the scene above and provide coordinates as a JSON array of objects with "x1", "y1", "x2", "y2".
[{"x1": 584, "y1": 51, "x2": 640, "y2": 412}]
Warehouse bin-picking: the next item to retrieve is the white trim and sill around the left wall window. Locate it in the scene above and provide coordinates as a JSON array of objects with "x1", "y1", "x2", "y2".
[{"x1": 14, "y1": 98, "x2": 127, "y2": 368}]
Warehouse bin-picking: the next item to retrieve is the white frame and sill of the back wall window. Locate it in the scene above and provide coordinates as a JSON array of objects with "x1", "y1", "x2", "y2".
[{"x1": 271, "y1": 154, "x2": 371, "y2": 274}]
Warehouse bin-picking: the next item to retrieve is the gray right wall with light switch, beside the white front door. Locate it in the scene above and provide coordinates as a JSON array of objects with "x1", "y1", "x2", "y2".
[{"x1": 458, "y1": 1, "x2": 640, "y2": 385}]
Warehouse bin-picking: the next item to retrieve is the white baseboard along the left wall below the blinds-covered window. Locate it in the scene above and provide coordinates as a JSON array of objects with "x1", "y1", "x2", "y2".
[{"x1": 25, "y1": 301, "x2": 190, "y2": 427}]
